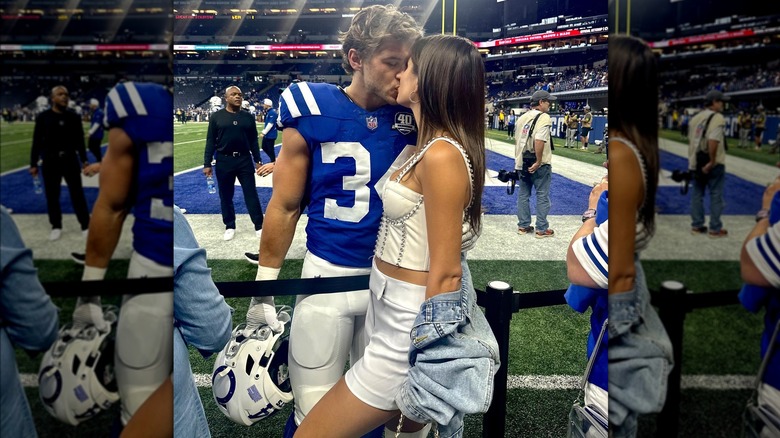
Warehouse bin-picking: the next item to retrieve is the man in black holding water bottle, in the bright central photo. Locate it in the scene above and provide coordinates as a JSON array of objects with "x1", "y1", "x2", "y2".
[{"x1": 203, "y1": 85, "x2": 263, "y2": 240}]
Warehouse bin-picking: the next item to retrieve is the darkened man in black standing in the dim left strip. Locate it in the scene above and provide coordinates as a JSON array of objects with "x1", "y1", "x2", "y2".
[{"x1": 30, "y1": 85, "x2": 89, "y2": 240}]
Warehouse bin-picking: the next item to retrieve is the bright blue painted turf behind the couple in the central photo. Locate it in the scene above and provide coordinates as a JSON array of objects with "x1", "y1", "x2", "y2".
[{"x1": 173, "y1": 151, "x2": 590, "y2": 215}]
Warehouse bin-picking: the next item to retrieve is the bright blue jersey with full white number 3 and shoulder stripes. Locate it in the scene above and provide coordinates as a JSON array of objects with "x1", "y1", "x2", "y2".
[{"x1": 279, "y1": 82, "x2": 417, "y2": 267}]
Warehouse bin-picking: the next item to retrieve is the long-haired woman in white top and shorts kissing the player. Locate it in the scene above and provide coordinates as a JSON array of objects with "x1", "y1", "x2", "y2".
[{"x1": 296, "y1": 35, "x2": 498, "y2": 437}]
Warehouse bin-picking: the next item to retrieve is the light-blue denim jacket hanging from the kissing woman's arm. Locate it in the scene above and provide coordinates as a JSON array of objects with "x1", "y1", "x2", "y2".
[{"x1": 395, "y1": 255, "x2": 500, "y2": 438}]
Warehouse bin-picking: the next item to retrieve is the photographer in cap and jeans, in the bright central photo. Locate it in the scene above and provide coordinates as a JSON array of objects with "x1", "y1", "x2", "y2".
[{"x1": 515, "y1": 90, "x2": 556, "y2": 239}]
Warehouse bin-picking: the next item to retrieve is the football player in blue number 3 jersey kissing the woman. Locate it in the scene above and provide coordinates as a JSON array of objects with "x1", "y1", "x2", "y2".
[{"x1": 247, "y1": 5, "x2": 422, "y2": 436}]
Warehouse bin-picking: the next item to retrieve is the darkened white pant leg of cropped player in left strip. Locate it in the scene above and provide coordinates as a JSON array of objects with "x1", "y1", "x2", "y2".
[{"x1": 115, "y1": 292, "x2": 173, "y2": 424}]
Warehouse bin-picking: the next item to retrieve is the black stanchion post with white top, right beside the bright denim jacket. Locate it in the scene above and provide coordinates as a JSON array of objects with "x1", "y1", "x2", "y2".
[{"x1": 482, "y1": 281, "x2": 514, "y2": 437}]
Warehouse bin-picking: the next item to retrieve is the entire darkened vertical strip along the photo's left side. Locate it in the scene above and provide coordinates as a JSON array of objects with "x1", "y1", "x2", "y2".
[{"x1": 0, "y1": 0, "x2": 173, "y2": 436}]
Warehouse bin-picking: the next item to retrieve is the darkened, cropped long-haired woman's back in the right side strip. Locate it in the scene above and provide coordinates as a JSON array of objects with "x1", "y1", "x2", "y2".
[{"x1": 608, "y1": 35, "x2": 672, "y2": 437}]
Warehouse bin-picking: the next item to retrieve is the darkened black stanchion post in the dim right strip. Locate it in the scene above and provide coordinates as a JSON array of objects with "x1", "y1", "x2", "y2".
[{"x1": 656, "y1": 281, "x2": 688, "y2": 438}]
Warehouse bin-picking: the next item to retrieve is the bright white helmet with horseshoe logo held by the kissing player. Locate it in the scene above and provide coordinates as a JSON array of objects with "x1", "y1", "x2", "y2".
[{"x1": 211, "y1": 306, "x2": 293, "y2": 426}]
